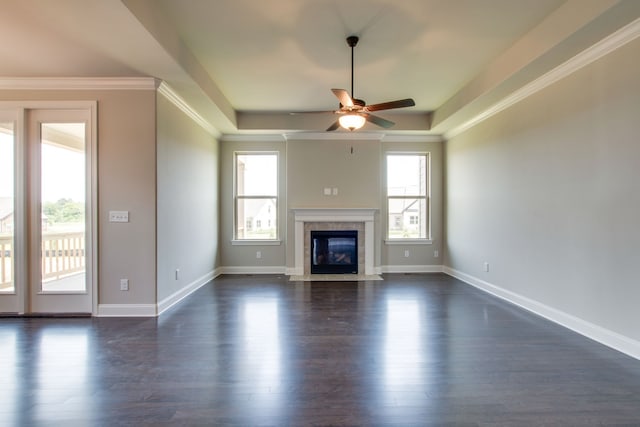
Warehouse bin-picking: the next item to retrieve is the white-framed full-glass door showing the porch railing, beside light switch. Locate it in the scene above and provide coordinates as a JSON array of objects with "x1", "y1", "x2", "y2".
[{"x1": 28, "y1": 110, "x2": 92, "y2": 313}]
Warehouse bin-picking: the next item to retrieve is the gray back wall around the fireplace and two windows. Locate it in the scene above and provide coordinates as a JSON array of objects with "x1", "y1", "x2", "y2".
[{"x1": 220, "y1": 135, "x2": 443, "y2": 272}]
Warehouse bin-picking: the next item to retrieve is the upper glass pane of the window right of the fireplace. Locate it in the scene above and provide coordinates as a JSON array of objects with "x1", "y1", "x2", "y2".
[{"x1": 387, "y1": 154, "x2": 427, "y2": 196}]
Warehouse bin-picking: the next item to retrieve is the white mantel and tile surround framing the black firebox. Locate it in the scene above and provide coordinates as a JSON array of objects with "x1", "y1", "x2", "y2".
[{"x1": 291, "y1": 208, "x2": 377, "y2": 276}]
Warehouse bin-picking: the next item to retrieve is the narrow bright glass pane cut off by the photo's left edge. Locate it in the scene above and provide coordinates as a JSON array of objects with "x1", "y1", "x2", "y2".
[{"x1": 0, "y1": 123, "x2": 15, "y2": 292}]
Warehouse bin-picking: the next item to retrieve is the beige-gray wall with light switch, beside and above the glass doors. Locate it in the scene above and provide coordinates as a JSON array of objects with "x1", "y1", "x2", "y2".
[{"x1": 0, "y1": 89, "x2": 156, "y2": 305}]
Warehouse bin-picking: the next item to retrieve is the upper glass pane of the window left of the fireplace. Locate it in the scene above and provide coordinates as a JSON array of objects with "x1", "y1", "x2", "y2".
[{"x1": 236, "y1": 154, "x2": 278, "y2": 196}]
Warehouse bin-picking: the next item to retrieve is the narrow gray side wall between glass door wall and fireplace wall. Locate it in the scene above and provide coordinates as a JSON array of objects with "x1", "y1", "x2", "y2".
[{"x1": 157, "y1": 95, "x2": 219, "y2": 302}]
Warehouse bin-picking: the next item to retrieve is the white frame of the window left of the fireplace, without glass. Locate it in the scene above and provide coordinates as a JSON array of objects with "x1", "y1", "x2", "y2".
[{"x1": 231, "y1": 150, "x2": 280, "y2": 245}]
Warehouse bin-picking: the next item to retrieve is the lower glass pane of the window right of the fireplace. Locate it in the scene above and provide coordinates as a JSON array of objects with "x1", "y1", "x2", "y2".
[{"x1": 387, "y1": 198, "x2": 428, "y2": 239}]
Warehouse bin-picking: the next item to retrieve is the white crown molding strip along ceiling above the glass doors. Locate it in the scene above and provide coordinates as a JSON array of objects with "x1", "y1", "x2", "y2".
[{"x1": 0, "y1": 77, "x2": 159, "y2": 90}]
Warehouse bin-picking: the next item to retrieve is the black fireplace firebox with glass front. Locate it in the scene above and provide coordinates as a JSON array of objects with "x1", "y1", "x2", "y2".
[{"x1": 310, "y1": 230, "x2": 358, "y2": 274}]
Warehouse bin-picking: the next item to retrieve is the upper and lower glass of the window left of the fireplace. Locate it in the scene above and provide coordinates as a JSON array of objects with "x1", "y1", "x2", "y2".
[{"x1": 234, "y1": 152, "x2": 278, "y2": 240}]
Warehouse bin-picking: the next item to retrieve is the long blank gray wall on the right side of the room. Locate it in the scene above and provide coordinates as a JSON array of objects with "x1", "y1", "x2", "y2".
[{"x1": 445, "y1": 40, "x2": 640, "y2": 340}]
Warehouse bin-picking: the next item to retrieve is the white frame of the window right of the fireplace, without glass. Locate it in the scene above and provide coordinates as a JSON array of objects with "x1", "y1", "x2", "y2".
[{"x1": 383, "y1": 151, "x2": 433, "y2": 245}]
